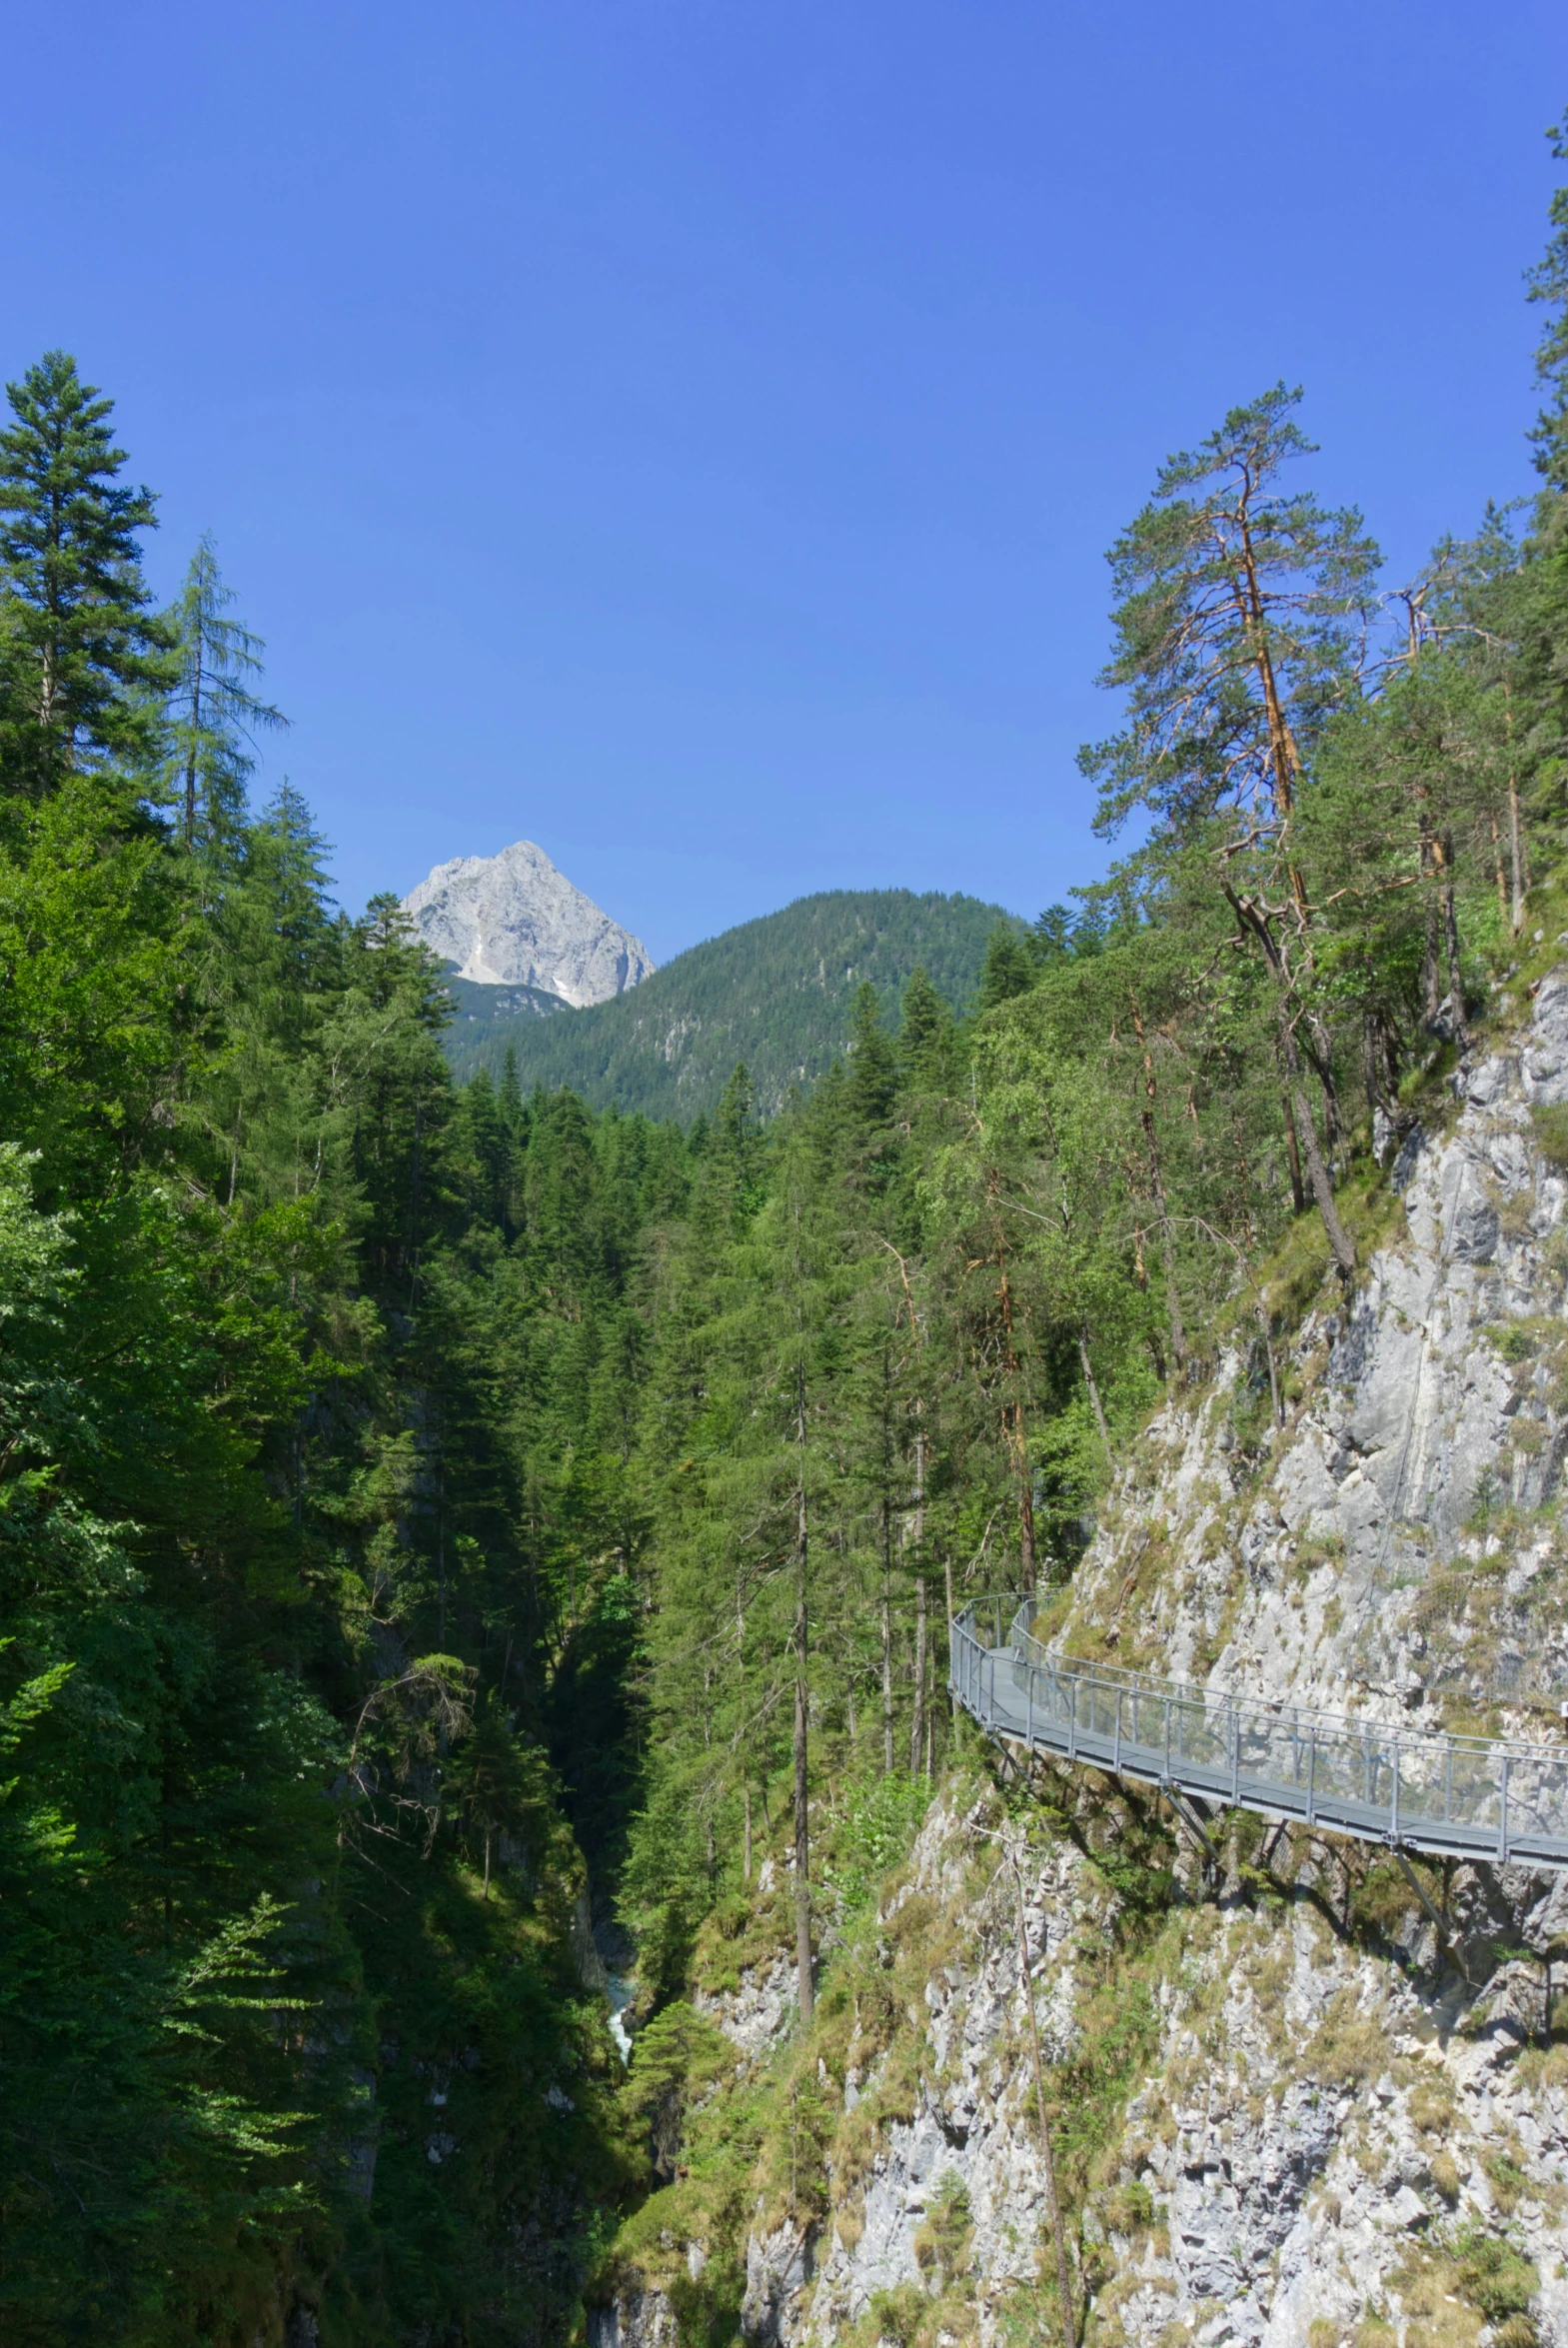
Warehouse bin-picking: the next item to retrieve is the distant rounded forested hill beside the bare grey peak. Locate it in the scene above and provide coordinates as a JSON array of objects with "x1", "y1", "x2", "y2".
[{"x1": 449, "y1": 888, "x2": 1009, "y2": 1123}]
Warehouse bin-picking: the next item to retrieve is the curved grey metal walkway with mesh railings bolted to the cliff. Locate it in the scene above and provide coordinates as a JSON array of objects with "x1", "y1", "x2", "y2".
[{"x1": 948, "y1": 1599, "x2": 1568, "y2": 1866}]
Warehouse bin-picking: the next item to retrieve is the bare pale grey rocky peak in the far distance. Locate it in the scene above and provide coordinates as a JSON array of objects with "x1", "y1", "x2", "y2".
[{"x1": 404, "y1": 841, "x2": 653, "y2": 1010}]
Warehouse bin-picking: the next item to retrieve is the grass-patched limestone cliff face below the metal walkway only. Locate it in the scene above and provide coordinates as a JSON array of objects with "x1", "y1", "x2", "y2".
[{"x1": 590, "y1": 1780, "x2": 1568, "y2": 2348}]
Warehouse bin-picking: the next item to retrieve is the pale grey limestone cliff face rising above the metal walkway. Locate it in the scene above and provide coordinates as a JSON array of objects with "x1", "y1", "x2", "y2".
[{"x1": 1042, "y1": 972, "x2": 1568, "y2": 1735}]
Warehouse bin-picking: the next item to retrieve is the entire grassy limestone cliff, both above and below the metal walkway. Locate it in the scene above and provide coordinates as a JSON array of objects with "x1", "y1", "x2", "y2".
[{"x1": 590, "y1": 975, "x2": 1568, "y2": 2348}]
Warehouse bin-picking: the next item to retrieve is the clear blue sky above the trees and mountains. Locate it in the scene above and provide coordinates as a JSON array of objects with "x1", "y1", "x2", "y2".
[{"x1": 0, "y1": 0, "x2": 1568, "y2": 958}]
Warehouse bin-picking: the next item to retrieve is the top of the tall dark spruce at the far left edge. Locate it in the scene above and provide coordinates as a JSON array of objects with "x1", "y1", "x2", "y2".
[{"x1": 0, "y1": 350, "x2": 171, "y2": 796}]
